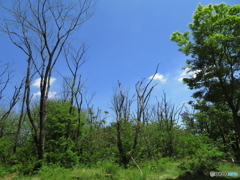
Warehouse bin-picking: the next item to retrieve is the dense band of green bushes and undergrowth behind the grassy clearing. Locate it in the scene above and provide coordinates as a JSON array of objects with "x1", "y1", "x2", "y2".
[{"x1": 0, "y1": 97, "x2": 235, "y2": 176}]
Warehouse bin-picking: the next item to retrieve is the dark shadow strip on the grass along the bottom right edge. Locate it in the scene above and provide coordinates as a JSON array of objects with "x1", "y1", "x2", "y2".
[{"x1": 166, "y1": 174, "x2": 240, "y2": 180}]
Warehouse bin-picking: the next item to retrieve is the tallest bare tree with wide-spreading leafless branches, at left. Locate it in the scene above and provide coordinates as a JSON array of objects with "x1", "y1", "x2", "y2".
[{"x1": 0, "y1": 0, "x2": 95, "y2": 169}]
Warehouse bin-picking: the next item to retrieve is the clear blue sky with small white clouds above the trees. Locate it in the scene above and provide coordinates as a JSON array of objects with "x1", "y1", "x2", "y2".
[{"x1": 0, "y1": 0, "x2": 238, "y2": 124}]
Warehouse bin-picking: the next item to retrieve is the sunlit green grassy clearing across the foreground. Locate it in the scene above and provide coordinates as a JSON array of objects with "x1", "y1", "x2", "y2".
[{"x1": 0, "y1": 161, "x2": 240, "y2": 180}]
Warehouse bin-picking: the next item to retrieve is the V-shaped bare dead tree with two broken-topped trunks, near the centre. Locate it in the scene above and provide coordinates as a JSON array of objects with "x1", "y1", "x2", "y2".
[{"x1": 112, "y1": 64, "x2": 159, "y2": 167}]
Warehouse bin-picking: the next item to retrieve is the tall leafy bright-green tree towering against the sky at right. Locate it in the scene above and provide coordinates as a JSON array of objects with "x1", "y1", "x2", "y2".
[{"x1": 171, "y1": 3, "x2": 240, "y2": 158}]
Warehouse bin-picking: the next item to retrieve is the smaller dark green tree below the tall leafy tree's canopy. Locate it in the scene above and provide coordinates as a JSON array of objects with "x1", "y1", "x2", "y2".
[{"x1": 182, "y1": 100, "x2": 239, "y2": 158}]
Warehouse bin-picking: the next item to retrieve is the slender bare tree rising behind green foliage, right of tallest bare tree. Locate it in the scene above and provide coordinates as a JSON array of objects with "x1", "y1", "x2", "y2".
[{"x1": 59, "y1": 43, "x2": 88, "y2": 141}]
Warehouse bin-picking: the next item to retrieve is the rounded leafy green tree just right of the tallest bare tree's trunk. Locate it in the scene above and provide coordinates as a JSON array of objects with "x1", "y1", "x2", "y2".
[{"x1": 43, "y1": 100, "x2": 79, "y2": 167}]
